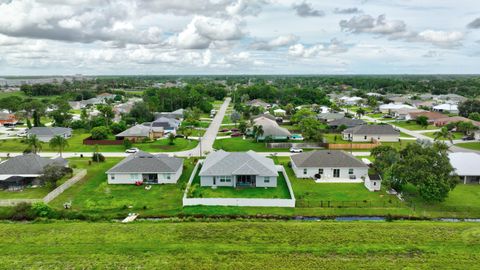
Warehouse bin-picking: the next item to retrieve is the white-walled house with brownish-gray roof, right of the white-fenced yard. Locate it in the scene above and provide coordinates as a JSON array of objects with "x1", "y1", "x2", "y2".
[{"x1": 290, "y1": 150, "x2": 368, "y2": 182}]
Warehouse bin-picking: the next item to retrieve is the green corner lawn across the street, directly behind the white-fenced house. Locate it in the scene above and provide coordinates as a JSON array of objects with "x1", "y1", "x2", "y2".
[{"x1": 213, "y1": 137, "x2": 289, "y2": 152}]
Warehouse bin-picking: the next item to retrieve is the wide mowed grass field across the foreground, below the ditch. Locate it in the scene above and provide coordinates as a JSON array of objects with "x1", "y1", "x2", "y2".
[{"x1": 0, "y1": 221, "x2": 480, "y2": 269}]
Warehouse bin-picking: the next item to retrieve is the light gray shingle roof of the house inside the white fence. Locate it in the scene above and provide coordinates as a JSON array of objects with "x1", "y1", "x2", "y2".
[{"x1": 200, "y1": 150, "x2": 278, "y2": 176}]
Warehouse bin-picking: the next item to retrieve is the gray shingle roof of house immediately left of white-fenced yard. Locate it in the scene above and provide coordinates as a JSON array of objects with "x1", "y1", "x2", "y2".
[{"x1": 107, "y1": 151, "x2": 183, "y2": 173}]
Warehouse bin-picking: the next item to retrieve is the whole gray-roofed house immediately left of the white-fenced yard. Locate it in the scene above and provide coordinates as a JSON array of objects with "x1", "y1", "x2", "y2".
[{"x1": 106, "y1": 151, "x2": 183, "y2": 184}]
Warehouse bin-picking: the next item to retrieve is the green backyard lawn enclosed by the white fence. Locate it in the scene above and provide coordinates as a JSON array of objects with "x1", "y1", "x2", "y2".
[{"x1": 192, "y1": 168, "x2": 290, "y2": 199}]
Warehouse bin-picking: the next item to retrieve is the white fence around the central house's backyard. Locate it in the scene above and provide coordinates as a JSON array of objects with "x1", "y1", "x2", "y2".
[{"x1": 182, "y1": 161, "x2": 295, "y2": 207}]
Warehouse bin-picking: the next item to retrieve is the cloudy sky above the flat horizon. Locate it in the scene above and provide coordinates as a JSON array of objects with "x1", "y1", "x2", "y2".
[{"x1": 0, "y1": 0, "x2": 480, "y2": 75}]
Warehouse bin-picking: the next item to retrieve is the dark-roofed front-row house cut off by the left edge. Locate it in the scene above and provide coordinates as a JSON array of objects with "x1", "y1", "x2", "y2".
[{"x1": 0, "y1": 154, "x2": 68, "y2": 190}]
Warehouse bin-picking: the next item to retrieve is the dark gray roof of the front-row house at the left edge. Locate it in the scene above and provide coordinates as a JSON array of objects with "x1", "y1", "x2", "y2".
[{"x1": 0, "y1": 154, "x2": 67, "y2": 175}]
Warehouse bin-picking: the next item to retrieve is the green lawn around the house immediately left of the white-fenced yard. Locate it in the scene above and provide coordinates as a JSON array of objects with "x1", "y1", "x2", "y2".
[{"x1": 51, "y1": 158, "x2": 194, "y2": 217}]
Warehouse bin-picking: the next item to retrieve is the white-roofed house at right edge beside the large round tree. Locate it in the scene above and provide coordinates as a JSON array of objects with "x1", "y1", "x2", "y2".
[{"x1": 448, "y1": 152, "x2": 480, "y2": 184}]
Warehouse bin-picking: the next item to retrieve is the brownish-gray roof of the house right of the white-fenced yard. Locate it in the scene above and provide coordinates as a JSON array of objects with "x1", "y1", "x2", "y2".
[{"x1": 291, "y1": 150, "x2": 367, "y2": 168}]
